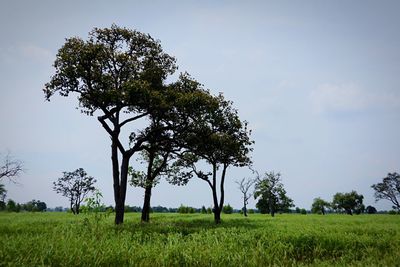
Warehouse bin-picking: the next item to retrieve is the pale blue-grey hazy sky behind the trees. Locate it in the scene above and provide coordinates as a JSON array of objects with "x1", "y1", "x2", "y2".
[{"x1": 0, "y1": 0, "x2": 400, "y2": 210}]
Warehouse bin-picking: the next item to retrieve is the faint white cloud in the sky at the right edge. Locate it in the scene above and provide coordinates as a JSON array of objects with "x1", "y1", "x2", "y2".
[{"x1": 310, "y1": 83, "x2": 400, "y2": 113}]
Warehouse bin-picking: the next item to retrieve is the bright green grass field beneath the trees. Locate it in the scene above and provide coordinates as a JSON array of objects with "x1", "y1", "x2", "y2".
[{"x1": 0, "y1": 213, "x2": 400, "y2": 266}]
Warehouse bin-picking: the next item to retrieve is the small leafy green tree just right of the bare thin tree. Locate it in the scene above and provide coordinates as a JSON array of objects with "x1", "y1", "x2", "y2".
[{"x1": 254, "y1": 172, "x2": 294, "y2": 217}]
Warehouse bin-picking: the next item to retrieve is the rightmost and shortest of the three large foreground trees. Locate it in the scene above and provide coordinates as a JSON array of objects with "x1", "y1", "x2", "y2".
[{"x1": 170, "y1": 94, "x2": 253, "y2": 224}]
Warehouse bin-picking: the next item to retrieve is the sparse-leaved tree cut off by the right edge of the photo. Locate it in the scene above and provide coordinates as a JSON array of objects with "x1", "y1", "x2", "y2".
[{"x1": 371, "y1": 172, "x2": 400, "y2": 211}]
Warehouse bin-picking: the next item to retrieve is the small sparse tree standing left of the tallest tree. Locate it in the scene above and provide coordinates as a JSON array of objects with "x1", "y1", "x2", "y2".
[{"x1": 53, "y1": 168, "x2": 96, "y2": 214}]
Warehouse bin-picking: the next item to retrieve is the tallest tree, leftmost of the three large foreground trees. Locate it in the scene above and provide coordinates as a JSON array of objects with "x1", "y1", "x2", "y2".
[{"x1": 44, "y1": 25, "x2": 176, "y2": 224}]
